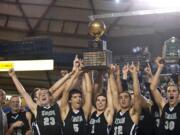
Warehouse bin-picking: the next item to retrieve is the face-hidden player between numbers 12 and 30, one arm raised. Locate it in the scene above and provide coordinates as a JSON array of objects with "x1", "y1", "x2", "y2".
[{"x1": 138, "y1": 64, "x2": 160, "y2": 135}]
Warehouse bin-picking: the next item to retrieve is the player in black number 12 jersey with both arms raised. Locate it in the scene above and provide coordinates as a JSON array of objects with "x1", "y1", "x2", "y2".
[{"x1": 110, "y1": 63, "x2": 141, "y2": 135}]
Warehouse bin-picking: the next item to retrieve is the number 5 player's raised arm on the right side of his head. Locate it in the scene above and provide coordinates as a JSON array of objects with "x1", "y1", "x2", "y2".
[{"x1": 83, "y1": 72, "x2": 92, "y2": 120}]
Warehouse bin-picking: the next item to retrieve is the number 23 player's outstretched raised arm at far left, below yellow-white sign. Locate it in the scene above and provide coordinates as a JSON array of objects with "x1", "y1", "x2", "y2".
[{"x1": 9, "y1": 69, "x2": 37, "y2": 116}]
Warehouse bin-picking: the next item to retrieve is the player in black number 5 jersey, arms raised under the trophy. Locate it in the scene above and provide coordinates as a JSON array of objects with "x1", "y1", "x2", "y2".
[{"x1": 61, "y1": 68, "x2": 92, "y2": 135}]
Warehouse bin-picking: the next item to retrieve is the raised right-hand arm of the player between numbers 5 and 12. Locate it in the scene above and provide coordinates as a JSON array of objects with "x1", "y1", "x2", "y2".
[{"x1": 104, "y1": 77, "x2": 114, "y2": 126}]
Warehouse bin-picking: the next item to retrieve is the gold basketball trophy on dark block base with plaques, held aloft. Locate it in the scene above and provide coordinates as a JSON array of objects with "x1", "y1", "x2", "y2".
[{"x1": 83, "y1": 20, "x2": 112, "y2": 70}]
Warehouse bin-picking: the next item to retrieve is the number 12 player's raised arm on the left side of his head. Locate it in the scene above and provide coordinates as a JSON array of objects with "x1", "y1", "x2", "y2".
[{"x1": 109, "y1": 65, "x2": 120, "y2": 111}]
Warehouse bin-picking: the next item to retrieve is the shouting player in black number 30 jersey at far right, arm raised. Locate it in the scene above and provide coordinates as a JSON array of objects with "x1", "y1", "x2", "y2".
[{"x1": 150, "y1": 57, "x2": 180, "y2": 135}]
